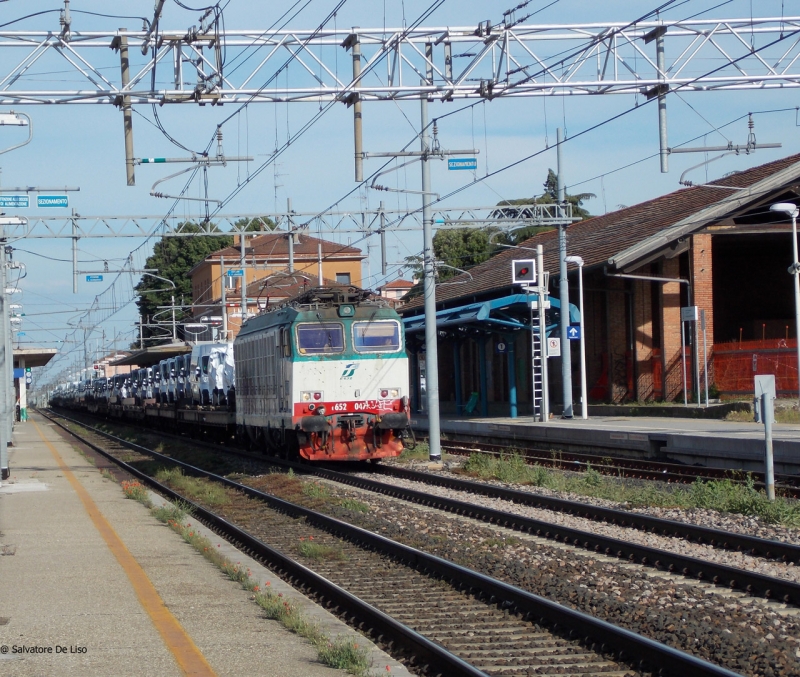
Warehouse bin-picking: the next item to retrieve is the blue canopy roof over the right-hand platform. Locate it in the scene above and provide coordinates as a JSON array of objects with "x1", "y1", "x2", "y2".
[{"x1": 403, "y1": 294, "x2": 580, "y2": 335}]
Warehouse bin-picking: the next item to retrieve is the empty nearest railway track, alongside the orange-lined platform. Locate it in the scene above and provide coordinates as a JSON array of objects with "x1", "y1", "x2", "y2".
[{"x1": 43, "y1": 406, "x2": 736, "y2": 677}]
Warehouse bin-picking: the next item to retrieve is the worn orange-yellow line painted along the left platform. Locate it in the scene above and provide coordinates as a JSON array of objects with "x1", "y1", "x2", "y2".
[{"x1": 32, "y1": 421, "x2": 216, "y2": 676}]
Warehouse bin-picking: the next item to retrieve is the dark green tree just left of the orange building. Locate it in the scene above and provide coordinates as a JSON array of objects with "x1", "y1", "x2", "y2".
[{"x1": 134, "y1": 223, "x2": 233, "y2": 338}]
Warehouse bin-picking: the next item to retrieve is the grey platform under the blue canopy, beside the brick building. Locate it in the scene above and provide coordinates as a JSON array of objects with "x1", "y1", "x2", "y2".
[{"x1": 411, "y1": 414, "x2": 800, "y2": 474}]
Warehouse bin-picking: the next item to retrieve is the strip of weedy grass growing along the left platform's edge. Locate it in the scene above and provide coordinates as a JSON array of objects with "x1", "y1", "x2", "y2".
[{"x1": 122, "y1": 478, "x2": 376, "y2": 677}]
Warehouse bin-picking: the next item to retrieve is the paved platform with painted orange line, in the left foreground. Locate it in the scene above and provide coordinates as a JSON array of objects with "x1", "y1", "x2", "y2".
[{"x1": 0, "y1": 414, "x2": 409, "y2": 677}]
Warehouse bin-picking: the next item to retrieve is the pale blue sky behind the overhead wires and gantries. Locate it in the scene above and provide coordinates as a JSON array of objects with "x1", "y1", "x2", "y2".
[{"x1": 0, "y1": 0, "x2": 800, "y2": 386}]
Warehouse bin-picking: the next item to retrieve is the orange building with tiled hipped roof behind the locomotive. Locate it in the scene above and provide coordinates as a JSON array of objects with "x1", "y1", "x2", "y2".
[{"x1": 190, "y1": 232, "x2": 366, "y2": 339}]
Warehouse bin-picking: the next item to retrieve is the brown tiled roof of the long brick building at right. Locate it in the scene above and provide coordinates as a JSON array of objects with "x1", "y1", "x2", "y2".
[{"x1": 405, "y1": 154, "x2": 800, "y2": 312}]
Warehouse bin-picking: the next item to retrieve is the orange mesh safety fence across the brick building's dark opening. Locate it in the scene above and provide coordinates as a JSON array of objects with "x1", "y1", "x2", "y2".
[{"x1": 713, "y1": 339, "x2": 798, "y2": 395}]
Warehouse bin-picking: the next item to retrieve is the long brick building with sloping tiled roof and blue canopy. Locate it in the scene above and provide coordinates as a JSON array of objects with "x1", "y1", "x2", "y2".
[{"x1": 401, "y1": 155, "x2": 800, "y2": 416}]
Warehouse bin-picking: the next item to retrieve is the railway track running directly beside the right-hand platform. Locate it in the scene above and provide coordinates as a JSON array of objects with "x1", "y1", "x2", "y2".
[{"x1": 432, "y1": 437, "x2": 800, "y2": 498}]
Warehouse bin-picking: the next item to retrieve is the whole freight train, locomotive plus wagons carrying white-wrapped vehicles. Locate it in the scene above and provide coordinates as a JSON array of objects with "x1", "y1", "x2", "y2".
[{"x1": 50, "y1": 287, "x2": 410, "y2": 461}]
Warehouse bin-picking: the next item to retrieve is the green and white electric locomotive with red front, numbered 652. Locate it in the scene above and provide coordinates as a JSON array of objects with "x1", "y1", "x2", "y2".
[{"x1": 233, "y1": 287, "x2": 409, "y2": 461}]
